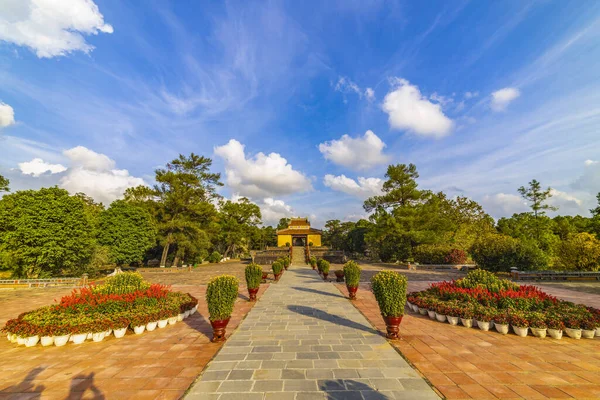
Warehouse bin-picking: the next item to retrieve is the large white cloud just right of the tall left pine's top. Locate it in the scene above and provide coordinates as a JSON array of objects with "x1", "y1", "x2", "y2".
[{"x1": 214, "y1": 139, "x2": 312, "y2": 198}]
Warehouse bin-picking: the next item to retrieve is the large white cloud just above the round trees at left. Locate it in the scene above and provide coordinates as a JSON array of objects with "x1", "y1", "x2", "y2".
[{"x1": 60, "y1": 146, "x2": 146, "y2": 204}]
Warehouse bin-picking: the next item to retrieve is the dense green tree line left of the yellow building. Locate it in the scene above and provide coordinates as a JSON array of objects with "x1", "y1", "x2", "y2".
[{"x1": 0, "y1": 157, "x2": 276, "y2": 278}]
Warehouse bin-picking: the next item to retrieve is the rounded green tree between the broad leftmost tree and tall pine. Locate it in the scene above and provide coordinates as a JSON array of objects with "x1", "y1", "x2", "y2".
[{"x1": 98, "y1": 200, "x2": 157, "y2": 265}]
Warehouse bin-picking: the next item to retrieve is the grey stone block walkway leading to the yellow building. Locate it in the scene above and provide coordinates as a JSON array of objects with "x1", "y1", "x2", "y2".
[{"x1": 187, "y1": 265, "x2": 439, "y2": 400}]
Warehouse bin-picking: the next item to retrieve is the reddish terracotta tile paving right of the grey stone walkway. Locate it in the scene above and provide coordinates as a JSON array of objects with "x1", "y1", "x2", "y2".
[{"x1": 336, "y1": 282, "x2": 600, "y2": 399}]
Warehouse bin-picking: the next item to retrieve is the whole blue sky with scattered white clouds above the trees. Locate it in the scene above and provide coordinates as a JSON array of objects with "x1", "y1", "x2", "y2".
[{"x1": 0, "y1": 0, "x2": 600, "y2": 226}]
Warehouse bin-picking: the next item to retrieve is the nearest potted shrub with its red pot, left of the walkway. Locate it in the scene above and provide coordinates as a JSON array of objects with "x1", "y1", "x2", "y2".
[{"x1": 206, "y1": 276, "x2": 237, "y2": 342}]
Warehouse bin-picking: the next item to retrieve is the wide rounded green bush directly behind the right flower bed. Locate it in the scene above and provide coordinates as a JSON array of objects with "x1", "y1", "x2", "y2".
[{"x1": 470, "y1": 234, "x2": 548, "y2": 272}]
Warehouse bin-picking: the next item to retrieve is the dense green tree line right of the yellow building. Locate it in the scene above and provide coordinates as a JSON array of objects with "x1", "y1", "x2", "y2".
[{"x1": 323, "y1": 164, "x2": 600, "y2": 271}]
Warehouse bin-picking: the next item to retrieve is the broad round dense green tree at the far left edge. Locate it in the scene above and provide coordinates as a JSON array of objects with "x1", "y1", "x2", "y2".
[{"x1": 0, "y1": 187, "x2": 96, "y2": 278}]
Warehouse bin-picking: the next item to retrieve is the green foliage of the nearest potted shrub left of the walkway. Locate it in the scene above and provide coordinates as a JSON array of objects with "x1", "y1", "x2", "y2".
[{"x1": 206, "y1": 275, "x2": 239, "y2": 321}]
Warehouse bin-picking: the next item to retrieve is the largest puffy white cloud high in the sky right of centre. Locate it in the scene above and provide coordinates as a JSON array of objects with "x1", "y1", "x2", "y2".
[{"x1": 383, "y1": 78, "x2": 454, "y2": 138}]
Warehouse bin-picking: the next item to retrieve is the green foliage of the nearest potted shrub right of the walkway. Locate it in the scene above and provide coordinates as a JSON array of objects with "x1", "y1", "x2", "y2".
[{"x1": 371, "y1": 271, "x2": 408, "y2": 317}]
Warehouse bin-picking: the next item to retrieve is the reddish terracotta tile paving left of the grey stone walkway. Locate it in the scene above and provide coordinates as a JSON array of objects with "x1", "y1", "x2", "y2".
[{"x1": 0, "y1": 284, "x2": 268, "y2": 399}]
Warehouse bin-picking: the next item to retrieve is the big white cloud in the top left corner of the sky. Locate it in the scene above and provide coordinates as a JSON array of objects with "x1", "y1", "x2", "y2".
[{"x1": 0, "y1": 0, "x2": 113, "y2": 58}]
